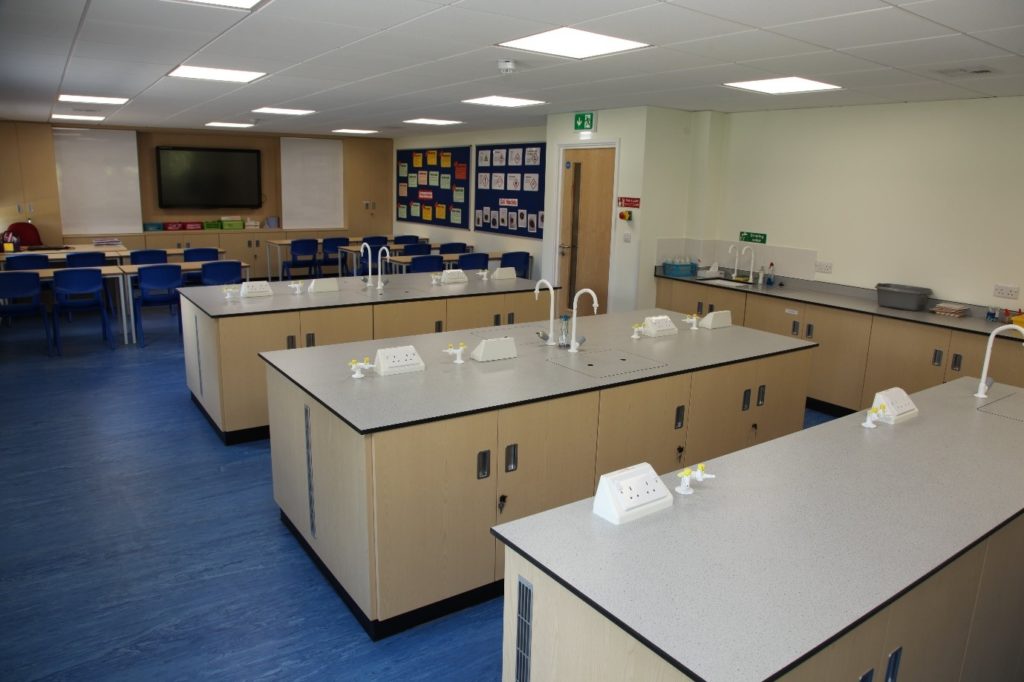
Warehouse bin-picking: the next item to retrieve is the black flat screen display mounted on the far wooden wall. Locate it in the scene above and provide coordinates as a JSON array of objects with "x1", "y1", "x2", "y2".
[{"x1": 157, "y1": 146, "x2": 263, "y2": 209}]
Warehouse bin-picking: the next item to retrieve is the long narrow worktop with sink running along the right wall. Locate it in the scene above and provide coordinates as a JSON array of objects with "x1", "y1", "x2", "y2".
[{"x1": 654, "y1": 266, "x2": 999, "y2": 334}]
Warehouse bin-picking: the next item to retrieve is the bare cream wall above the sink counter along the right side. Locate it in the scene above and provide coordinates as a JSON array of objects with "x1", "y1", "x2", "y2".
[{"x1": 712, "y1": 97, "x2": 1024, "y2": 307}]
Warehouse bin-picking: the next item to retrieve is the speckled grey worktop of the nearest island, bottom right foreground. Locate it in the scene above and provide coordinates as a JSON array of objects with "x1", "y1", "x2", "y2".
[{"x1": 494, "y1": 379, "x2": 1024, "y2": 682}]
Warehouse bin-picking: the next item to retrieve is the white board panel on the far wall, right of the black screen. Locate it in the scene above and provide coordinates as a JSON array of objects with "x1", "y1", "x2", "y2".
[{"x1": 281, "y1": 137, "x2": 345, "y2": 229}]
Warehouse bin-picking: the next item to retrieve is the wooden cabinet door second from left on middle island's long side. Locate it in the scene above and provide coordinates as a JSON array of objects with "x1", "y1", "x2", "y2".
[{"x1": 494, "y1": 391, "x2": 599, "y2": 581}]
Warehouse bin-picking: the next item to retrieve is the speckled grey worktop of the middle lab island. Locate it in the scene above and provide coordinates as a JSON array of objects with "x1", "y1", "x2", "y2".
[{"x1": 260, "y1": 309, "x2": 816, "y2": 433}]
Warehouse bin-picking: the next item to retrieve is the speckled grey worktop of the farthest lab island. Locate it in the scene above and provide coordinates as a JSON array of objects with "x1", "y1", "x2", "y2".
[{"x1": 178, "y1": 272, "x2": 546, "y2": 317}]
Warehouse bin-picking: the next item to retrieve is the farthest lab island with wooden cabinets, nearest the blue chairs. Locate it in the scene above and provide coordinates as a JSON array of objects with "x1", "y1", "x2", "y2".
[{"x1": 180, "y1": 273, "x2": 548, "y2": 443}]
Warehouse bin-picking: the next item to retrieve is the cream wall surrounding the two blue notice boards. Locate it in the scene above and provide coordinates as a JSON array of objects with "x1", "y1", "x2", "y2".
[{"x1": 392, "y1": 127, "x2": 557, "y2": 278}]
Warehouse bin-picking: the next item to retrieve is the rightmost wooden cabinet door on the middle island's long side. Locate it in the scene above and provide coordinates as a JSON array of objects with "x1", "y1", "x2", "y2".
[{"x1": 752, "y1": 350, "x2": 812, "y2": 442}]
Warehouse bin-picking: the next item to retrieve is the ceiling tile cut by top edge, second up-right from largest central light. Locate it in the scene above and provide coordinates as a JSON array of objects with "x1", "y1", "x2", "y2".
[{"x1": 669, "y1": 0, "x2": 886, "y2": 27}]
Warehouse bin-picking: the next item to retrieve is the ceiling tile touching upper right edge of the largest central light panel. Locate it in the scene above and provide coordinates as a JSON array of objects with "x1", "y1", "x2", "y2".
[{"x1": 573, "y1": 3, "x2": 748, "y2": 45}]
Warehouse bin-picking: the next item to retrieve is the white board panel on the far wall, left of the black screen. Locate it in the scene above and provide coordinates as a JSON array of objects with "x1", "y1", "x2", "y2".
[{"x1": 53, "y1": 128, "x2": 142, "y2": 235}]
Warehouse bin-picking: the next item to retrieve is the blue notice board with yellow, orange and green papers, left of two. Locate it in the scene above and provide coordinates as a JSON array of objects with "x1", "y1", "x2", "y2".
[{"x1": 394, "y1": 146, "x2": 471, "y2": 229}]
